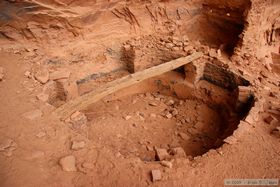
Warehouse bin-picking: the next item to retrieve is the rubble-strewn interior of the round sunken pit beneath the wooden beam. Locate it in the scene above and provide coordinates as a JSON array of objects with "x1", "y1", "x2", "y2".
[{"x1": 72, "y1": 62, "x2": 254, "y2": 161}]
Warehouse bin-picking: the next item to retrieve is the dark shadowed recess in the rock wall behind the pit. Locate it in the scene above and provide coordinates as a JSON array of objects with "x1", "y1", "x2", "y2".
[{"x1": 202, "y1": 0, "x2": 251, "y2": 56}]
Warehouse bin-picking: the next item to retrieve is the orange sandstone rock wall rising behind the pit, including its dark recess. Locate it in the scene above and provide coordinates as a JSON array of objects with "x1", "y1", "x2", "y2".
[{"x1": 0, "y1": 0, "x2": 280, "y2": 62}]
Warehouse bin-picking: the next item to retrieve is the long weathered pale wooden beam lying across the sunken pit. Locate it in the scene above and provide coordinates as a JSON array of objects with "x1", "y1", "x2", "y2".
[{"x1": 54, "y1": 52, "x2": 203, "y2": 120}]
